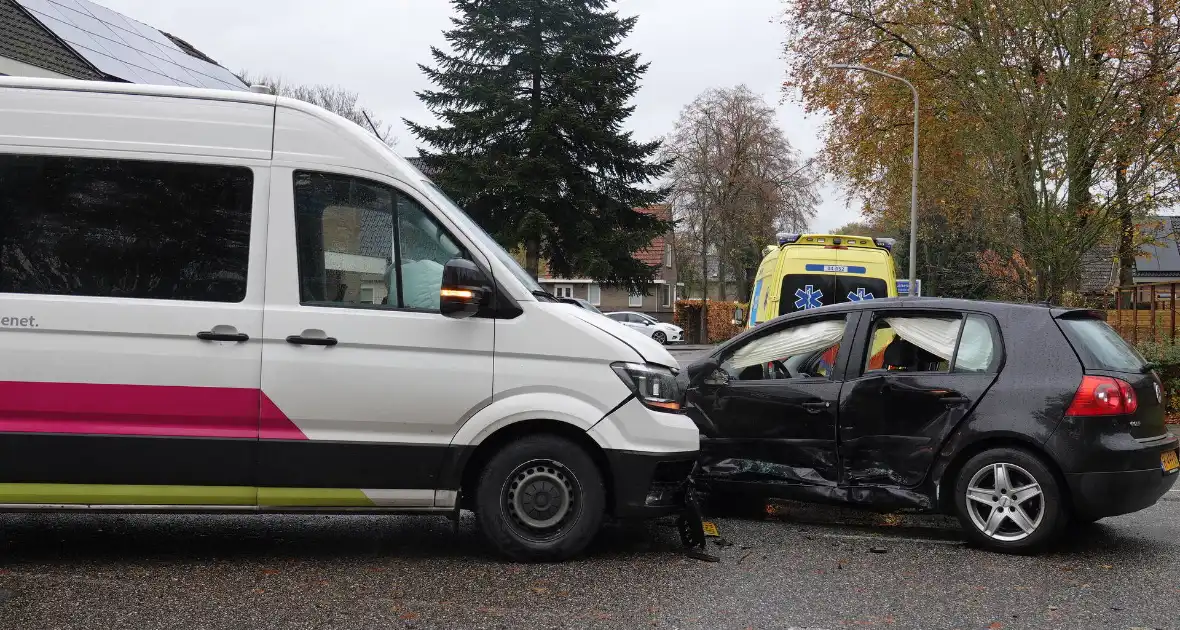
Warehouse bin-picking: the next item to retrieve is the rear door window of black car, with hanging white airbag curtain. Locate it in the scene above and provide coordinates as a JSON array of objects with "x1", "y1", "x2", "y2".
[{"x1": 864, "y1": 313, "x2": 962, "y2": 374}]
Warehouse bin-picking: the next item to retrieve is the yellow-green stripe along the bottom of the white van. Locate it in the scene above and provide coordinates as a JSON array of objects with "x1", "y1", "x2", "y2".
[{"x1": 0, "y1": 484, "x2": 376, "y2": 507}]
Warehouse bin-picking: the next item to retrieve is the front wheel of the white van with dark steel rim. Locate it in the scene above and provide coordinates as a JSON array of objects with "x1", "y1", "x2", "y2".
[{"x1": 476, "y1": 435, "x2": 607, "y2": 562}]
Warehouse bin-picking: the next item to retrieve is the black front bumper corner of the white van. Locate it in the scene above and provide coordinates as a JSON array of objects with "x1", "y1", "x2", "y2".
[{"x1": 607, "y1": 451, "x2": 697, "y2": 518}]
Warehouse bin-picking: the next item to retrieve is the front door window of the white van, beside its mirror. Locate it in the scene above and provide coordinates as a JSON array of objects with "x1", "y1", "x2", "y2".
[{"x1": 295, "y1": 171, "x2": 465, "y2": 311}]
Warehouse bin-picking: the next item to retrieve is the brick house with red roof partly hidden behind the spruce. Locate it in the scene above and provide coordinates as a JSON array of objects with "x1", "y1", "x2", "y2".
[{"x1": 538, "y1": 205, "x2": 681, "y2": 322}]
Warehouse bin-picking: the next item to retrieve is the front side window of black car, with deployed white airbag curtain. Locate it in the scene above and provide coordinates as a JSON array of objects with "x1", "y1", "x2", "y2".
[{"x1": 721, "y1": 317, "x2": 847, "y2": 381}]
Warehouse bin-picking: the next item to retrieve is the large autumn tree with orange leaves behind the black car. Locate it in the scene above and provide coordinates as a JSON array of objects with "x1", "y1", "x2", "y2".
[{"x1": 786, "y1": 0, "x2": 1180, "y2": 300}]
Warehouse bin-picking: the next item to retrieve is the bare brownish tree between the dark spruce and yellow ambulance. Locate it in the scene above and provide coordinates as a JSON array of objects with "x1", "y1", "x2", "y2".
[{"x1": 663, "y1": 85, "x2": 818, "y2": 341}]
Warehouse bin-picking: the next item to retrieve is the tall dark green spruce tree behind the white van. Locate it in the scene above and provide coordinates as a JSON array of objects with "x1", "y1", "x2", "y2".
[{"x1": 406, "y1": 0, "x2": 670, "y2": 290}]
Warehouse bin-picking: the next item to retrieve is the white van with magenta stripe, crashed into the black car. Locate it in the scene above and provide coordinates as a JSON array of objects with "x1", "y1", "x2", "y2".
[{"x1": 0, "y1": 77, "x2": 699, "y2": 559}]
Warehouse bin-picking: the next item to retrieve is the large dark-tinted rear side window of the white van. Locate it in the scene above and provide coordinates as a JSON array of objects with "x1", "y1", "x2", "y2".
[{"x1": 0, "y1": 155, "x2": 254, "y2": 302}]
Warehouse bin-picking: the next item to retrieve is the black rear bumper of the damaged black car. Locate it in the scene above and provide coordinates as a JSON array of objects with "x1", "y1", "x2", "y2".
[{"x1": 1066, "y1": 467, "x2": 1180, "y2": 518}]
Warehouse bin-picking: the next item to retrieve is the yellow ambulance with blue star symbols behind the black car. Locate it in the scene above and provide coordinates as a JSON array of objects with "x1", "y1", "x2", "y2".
[{"x1": 746, "y1": 234, "x2": 897, "y2": 328}]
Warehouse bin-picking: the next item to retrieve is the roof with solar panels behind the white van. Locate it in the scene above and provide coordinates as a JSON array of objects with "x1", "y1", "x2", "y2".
[{"x1": 0, "y1": 0, "x2": 249, "y2": 91}]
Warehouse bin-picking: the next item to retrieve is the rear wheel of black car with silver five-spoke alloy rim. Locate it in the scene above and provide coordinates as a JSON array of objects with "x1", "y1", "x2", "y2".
[{"x1": 955, "y1": 448, "x2": 1068, "y2": 553}]
